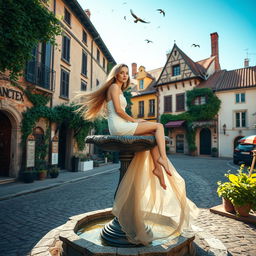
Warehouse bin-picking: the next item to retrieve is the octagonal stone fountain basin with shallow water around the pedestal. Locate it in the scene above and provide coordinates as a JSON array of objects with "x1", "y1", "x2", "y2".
[{"x1": 30, "y1": 208, "x2": 196, "y2": 256}]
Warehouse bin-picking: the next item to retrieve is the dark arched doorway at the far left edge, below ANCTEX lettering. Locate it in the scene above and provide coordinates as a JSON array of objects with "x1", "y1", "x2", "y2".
[{"x1": 0, "y1": 111, "x2": 12, "y2": 177}]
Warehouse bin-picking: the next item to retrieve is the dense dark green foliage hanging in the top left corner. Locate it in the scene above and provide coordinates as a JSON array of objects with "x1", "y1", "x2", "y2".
[{"x1": 0, "y1": 0, "x2": 61, "y2": 79}]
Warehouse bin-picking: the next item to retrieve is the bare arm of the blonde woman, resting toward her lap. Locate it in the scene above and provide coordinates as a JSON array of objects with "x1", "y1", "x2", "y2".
[{"x1": 109, "y1": 84, "x2": 138, "y2": 122}]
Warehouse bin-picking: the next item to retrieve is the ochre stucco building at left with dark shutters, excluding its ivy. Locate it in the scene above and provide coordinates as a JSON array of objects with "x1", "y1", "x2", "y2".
[{"x1": 0, "y1": 0, "x2": 115, "y2": 177}]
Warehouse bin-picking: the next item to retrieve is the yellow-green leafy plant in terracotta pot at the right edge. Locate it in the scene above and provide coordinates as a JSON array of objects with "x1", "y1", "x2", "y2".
[{"x1": 217, "y1": 165, "x2": 256, "y2": 217}]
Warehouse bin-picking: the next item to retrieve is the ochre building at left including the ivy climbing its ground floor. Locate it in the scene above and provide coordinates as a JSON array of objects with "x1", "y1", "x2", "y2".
[{"x1": 0, "y1": 0, "x2": 116, "y2": 177}]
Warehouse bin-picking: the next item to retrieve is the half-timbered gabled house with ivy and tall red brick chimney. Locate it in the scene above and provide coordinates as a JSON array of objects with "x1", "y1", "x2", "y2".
[{"x1": 156, "y1": 33, "x2": 220, "y2": 155}]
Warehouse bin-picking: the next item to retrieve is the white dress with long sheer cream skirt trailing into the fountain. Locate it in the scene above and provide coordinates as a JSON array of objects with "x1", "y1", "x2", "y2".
[{"x1": 107, "y1": 94, "x2": 198, "y2": 245}]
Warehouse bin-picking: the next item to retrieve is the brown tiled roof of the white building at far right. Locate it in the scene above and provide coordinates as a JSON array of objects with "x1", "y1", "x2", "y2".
[{"x1": 197, "y1": 66, "x2": 256, "y2": 91}]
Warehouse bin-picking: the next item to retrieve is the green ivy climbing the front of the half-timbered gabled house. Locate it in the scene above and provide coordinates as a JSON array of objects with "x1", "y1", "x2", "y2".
[{"x1": 160, "y1": 88, "x2": 221, "y2": 152}]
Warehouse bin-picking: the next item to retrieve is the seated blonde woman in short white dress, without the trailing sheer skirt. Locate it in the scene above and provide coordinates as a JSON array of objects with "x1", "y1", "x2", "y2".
[{"x1": 80, "y1": 64, "x2": 171, "y2": 189}]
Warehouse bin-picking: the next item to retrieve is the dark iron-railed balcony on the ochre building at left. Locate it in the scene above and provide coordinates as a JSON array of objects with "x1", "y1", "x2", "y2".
[{"x1": 25, "y1": 61, "x2": 56, "y2": 91}]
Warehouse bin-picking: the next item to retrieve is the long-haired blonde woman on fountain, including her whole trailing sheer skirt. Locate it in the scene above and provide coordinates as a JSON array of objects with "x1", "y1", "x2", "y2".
[{"x1": 79, "y1": 64, "x2": 197, "y2": 245}]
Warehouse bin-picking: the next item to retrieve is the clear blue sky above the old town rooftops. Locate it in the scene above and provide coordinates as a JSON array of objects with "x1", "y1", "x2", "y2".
[{"x1": 78, "y1": 0, "x2": 256, "y2": 70}]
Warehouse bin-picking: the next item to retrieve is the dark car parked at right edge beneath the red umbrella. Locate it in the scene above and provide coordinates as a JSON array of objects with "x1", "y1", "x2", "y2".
[{"x1": 233, "y1": 144, "x2": 256, "y2": 165}]
